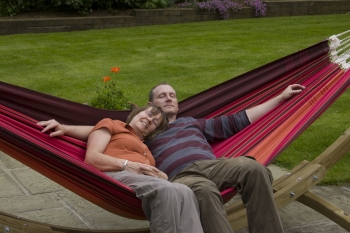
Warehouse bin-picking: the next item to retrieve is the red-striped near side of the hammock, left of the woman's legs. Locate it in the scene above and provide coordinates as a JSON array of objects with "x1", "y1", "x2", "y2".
[{"x1": 0, "y1": 105, "x2": 144, "y2": 219}]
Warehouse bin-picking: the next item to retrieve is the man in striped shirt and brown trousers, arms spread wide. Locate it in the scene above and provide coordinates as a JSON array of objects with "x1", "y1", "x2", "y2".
[{"x1": 38, "y1": 83, "x2": 305, "y2": 233}]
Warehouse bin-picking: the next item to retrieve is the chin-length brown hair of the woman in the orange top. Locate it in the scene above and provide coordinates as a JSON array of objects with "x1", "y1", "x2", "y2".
[{"x1": 126, "y1": 106, "x2": 169, "y2": 140}]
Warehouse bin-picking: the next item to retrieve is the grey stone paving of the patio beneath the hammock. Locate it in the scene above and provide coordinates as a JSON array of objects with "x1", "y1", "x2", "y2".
[{"x1": 0, "y1": 152, "x2": 350, "y2": 233}]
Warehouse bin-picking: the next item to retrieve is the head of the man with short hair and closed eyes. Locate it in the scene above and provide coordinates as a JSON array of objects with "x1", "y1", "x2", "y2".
[{"x1": 152, "y1": 85, "x2": 179, "y2": 118}]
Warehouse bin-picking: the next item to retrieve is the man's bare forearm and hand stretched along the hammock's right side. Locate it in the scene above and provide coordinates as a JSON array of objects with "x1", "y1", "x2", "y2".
[{"x1": 246, "y1": 84, "x2": 305, "y2": 123}]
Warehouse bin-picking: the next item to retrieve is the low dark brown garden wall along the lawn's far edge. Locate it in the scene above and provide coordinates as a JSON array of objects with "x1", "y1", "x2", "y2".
[{"x1": 0, "y1": 0, "x2": 350, "y2": 35}]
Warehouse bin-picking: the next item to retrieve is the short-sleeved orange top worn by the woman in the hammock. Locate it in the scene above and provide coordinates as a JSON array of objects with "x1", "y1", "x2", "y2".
[{"x1": 92, "y1": 118, "x2": 156, "y2": 166}]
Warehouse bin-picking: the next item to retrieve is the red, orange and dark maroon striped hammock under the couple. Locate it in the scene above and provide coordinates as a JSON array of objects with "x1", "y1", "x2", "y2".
[{"x1": 0, "y1": 31, "x2": 350, "y2": 219}]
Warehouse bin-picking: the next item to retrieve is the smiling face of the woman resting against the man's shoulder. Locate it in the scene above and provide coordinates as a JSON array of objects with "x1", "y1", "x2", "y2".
[{"x1": 129, "y1": 107, "x2": 162, "y2": 139}]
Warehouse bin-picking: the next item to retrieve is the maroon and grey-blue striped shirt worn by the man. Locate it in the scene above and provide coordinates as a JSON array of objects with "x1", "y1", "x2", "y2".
[{"x1": 146, "y1": 111, "x2": 250, "y2": 179}]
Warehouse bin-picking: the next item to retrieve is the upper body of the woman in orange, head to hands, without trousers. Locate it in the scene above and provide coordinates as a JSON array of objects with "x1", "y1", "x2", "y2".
[{"x1": 85, "y1": 106, "x2": 168, "y2": 180}]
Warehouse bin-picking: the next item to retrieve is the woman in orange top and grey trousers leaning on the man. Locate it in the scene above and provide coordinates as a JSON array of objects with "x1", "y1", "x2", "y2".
[{"x1": 38, "y1": 106, "x2": 203, "y2": 233}]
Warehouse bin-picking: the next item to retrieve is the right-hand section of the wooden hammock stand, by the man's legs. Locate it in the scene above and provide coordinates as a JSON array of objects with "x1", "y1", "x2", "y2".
[{"x1": 226, "y1": 128, "x2": 350, "y2": 232}]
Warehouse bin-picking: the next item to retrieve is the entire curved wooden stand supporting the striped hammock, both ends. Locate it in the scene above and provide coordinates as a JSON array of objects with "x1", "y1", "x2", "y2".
[{"x1": 0, "y1": 128, "x2": 350, "y2": 233}]
